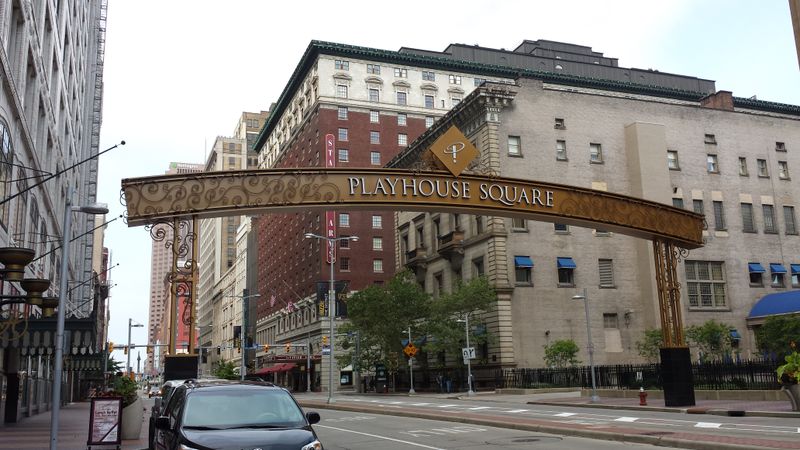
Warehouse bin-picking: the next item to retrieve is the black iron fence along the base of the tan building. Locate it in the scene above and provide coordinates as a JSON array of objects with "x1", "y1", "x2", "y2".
[{"x1": 495, "y1": 360, "x2": 780, "y2": 390}]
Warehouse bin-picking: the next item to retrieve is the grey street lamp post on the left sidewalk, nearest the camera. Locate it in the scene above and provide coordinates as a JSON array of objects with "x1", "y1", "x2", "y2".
[{"x1": 50, "y1": 186, "x2": 108, "y2": 450}]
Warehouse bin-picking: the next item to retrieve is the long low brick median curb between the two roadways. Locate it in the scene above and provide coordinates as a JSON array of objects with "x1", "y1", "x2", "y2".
[{"x1": 298, "y1": 400, "x2": 781, "y2": 450}]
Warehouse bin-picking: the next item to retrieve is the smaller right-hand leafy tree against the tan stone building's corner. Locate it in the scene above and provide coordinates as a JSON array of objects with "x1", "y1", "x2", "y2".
[{"x1": 423, "y1": 277, "x2": 497, "y2": 368}]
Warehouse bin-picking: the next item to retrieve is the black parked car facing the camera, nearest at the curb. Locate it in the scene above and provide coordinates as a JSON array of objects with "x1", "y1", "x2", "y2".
[{"x1": 155, "y1": 381, "x2": 322, "y2": 450}]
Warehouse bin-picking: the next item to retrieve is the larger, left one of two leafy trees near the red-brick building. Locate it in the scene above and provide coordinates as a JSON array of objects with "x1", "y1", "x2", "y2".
[{"x1": 336, "y1": 270, "x2": 430, "y2": 370}]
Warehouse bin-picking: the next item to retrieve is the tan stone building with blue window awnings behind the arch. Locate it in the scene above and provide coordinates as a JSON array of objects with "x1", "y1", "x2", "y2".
[{"x1": 389, "y1": 76, "x2": 800, "y2": 377}]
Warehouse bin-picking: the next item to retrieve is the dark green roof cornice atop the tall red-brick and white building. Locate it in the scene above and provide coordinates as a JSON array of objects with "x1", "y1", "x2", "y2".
[{"x1": 255, "y1": 40, "x2": 800, "y2": 150}]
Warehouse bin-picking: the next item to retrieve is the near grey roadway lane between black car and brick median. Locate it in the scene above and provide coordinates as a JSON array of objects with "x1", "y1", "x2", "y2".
[{"x1": 314, "y1": 410, "x2": 680, "y2": 450}]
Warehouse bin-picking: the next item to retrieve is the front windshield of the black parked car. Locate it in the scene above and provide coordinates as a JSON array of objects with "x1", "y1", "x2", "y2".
[{"x1": 183, "y1": 389, "x2": 306, "y2": 428}]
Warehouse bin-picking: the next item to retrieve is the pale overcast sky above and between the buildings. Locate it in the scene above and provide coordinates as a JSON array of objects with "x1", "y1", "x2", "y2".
[{"x1": 98, "y1": 0, "x2": 800, "y2": 368}]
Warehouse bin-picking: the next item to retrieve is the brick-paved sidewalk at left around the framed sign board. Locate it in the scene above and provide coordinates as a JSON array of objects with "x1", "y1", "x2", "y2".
[{"x1": 0, "y1": 402, "x2": 147, "y2": 450}]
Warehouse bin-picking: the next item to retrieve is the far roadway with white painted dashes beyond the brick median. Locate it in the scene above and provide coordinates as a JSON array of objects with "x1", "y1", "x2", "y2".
[{"x1": 298, "y1": 395, "x2": 800, "y2": 449}]
